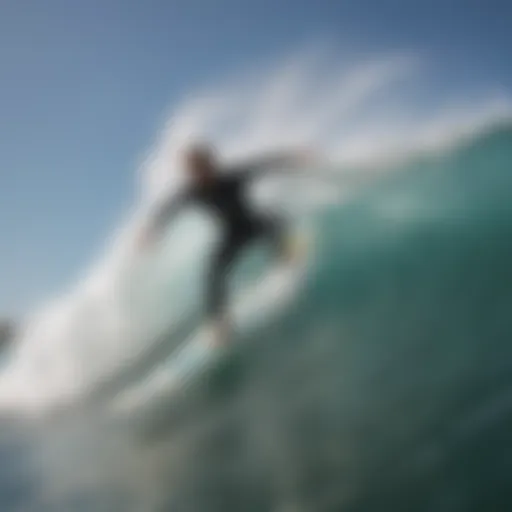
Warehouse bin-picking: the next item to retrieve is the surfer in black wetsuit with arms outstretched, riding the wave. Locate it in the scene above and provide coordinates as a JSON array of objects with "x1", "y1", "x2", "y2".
[{"x1": 141, "y1": 145, "x2": 305, "y2": 343}]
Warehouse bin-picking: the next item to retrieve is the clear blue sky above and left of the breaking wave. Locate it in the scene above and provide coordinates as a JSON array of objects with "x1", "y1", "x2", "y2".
[{"x1": 0, "y1": 0, "x2": 512, "y2": 316}]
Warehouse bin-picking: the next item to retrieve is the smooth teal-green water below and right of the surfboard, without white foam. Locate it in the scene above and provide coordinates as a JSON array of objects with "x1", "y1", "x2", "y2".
[{"x1": 0, "y1": 124, "x2": 512, "y2": 512}]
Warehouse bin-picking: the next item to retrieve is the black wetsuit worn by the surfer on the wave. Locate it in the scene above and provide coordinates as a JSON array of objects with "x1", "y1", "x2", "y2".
[{"x1": 154, "y1": 160, "x2": 283, "y2": 318}]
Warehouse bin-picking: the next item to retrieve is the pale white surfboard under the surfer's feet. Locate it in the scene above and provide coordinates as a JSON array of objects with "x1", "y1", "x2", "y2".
[{"x1": 112, "y1": 233, "x2": 311, "y2": 413}]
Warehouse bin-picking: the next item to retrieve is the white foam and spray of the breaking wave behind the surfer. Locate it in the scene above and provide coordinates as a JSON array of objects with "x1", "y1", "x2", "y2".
[{"x1": 0, "y1": 44, "x2": 512, "y2": 418}]
